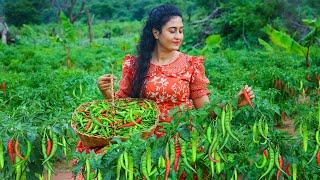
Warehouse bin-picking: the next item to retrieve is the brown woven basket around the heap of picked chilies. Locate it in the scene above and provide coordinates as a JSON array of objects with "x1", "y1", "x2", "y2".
[{"x1": 71, "y1": 98, "x2": 160, "y2": 148}]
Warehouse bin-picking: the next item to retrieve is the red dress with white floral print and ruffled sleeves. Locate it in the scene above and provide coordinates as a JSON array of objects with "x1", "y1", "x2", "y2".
[{"x1": 115, "y1": 53, "x2": 209, "y2": 122}]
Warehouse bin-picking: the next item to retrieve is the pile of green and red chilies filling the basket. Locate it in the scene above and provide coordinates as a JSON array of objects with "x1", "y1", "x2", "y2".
[{"x1": 73, "y1": 99, "x2": 158, "y2": 137}]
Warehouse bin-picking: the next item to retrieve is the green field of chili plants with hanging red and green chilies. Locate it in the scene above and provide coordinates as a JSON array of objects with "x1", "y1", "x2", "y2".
[{"x1": 0, "y1": 19, "x2": 320, "y2": 179}]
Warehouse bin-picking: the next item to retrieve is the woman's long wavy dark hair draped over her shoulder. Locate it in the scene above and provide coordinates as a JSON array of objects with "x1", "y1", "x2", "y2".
[{"x1": 131, "y1": 5, "x2": 182, "y2": 98}]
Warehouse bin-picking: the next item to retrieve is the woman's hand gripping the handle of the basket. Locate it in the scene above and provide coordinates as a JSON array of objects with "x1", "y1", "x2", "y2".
[{"x1": 97, "y1": 74, "x2": 114, "y2": 99}]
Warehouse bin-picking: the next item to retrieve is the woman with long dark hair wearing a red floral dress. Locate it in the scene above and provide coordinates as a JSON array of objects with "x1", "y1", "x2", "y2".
[{"x1": 98, "y1": 5, "x2": 254, "y2": 122}]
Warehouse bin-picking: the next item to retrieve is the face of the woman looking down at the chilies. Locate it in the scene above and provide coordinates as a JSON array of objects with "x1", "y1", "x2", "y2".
[{"x1": 153, "y1": 16, "x2": 183, "y2": 51}]
